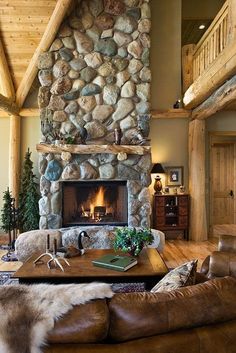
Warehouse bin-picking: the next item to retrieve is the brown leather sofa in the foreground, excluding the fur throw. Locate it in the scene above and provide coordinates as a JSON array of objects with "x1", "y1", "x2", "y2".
[{"x1": 44, "y1": 277, "x2": 236, "y2": 353}]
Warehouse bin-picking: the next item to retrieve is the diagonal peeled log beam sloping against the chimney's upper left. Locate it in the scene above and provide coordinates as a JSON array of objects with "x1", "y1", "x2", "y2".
[{"x1": 16, "y1": 0, "x2": 73, "y2": 107}]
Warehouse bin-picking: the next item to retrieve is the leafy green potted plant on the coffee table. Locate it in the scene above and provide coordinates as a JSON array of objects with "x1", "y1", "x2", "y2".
[{"x1": 114, "y1": 227, "x2": 154, "y2": 256}]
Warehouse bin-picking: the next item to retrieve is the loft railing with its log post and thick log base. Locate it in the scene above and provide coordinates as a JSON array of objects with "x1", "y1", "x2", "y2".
[{"x1": 182, "y1": 0, "x2": 236, "y2": 109}]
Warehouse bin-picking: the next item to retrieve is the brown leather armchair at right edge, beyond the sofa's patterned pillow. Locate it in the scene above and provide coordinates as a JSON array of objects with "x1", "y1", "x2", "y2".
[{"x1": 201, "y1": 235, "x2": 236, "y2": 279}]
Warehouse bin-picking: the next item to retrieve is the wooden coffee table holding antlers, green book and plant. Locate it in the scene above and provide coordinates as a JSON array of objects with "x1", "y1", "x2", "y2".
[{"x1": 13, "y1": 248, "x2": 168, "y2": 289}]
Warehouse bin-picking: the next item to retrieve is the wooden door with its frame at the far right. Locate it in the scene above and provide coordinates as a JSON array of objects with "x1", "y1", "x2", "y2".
[{"x1": 209, "y1": 132, "x2": 236, "y2": 236}]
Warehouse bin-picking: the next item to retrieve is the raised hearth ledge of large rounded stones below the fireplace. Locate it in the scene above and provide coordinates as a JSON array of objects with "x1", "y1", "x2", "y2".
[{"x1": 15, "y1": 226, "x2": 165, "y2": 262}]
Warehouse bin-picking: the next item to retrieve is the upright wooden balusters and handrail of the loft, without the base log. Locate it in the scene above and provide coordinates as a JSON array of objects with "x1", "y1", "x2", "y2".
[{"x1": 193, "y1": 1, "x2": 229, "y2": 81}]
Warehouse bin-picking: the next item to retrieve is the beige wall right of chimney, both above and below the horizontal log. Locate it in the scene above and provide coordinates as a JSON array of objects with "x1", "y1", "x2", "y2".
[{"x1": 150, "y1": 0, "x2": 188, "y2": 192}]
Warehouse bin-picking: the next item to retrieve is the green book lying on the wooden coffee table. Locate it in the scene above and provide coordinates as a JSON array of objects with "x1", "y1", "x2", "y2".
[{"x1": 92, "y1": 254, "x2": 138, "y2": 272}]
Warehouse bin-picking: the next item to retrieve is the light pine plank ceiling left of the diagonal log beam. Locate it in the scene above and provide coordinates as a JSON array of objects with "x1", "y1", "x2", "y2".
[{"x1": 0, "y1": 0, "x2": 57, "y2": 90}]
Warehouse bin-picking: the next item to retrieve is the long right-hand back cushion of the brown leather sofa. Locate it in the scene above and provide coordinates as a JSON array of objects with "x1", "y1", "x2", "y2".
[{"x1": 109, "y1": 277, "x2": 236, "y2": 341}]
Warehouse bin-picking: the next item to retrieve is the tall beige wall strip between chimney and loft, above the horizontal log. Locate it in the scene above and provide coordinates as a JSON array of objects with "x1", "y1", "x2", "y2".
[{"x1": 151, "y1": 0, "x2": 181, "y2": 109}]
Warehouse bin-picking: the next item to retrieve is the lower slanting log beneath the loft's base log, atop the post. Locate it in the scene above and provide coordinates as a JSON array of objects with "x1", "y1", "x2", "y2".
[{"x1": 192, "y1": 75, "x2": 236, "y2": 119}]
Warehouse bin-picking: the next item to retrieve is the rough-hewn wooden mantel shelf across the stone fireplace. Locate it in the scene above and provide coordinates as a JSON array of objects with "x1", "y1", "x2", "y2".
[{"x1": 36, "y1": 143, "x2": 151, "y2": 155}]
